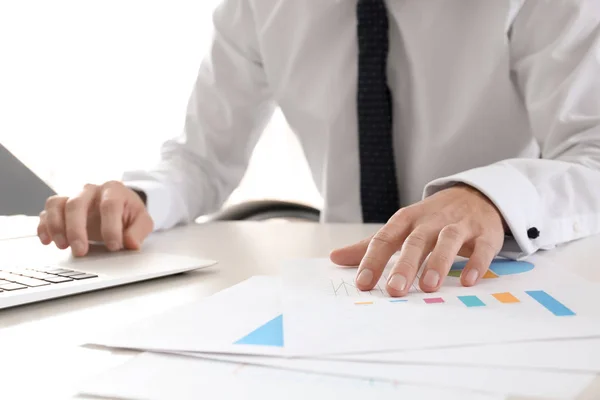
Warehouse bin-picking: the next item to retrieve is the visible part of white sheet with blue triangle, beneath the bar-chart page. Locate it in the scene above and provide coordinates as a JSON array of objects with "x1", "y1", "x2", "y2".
[{"x1": 89, "y1": 277, "x2": 283, "y2": 355}]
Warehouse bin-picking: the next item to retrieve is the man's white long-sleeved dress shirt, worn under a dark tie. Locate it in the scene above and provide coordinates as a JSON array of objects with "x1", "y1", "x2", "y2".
[{"x1": 124, "y1": 0, "x2": 600, "y2": 258}]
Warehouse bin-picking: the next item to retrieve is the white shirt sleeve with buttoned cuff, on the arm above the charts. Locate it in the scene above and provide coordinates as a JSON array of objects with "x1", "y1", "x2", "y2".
[{"x1": 423, "y1": 0, "x2": 600, "y2": 258}]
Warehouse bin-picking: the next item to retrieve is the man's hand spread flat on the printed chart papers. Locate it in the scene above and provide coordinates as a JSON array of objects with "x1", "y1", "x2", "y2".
[{"x1": 331, "y1": 184, "x2": 505, "y2": 296}]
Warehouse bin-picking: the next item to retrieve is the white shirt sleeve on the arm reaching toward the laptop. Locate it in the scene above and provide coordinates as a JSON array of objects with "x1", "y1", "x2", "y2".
[{"x1": 123, "y1": 0, "x2": 274, "y2": 230}]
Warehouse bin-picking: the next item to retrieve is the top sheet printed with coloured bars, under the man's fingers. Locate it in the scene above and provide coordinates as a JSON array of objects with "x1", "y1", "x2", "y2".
[{"x1": 281, "y1": 258, "x2": 600, "y2": 356}]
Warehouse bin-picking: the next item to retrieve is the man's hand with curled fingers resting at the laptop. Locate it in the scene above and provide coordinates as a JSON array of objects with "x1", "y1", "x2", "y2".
[{"x1": 38, "y1": 181, "x2": 154, "y2": 257}]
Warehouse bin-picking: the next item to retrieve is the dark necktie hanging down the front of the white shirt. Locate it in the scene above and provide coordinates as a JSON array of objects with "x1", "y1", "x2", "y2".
[{"x1": 356, "y1": 0, "x2": 400, "y2": 223}]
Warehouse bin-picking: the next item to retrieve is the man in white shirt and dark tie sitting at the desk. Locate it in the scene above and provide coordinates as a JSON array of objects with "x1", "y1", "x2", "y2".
[{"x1": 38, "y1": 0, "x2": 600, "y2": 296}]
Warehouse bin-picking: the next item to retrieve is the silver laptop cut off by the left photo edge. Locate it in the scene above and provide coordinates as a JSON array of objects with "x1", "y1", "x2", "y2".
[{"x1": 0, "y1": 145, "x2": 216, "y2": 310}]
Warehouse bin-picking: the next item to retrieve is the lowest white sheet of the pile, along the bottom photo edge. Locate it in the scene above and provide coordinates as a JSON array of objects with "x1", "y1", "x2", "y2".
[{"x1": 81, "y1": 353, "x2": 504, "y2": 400}]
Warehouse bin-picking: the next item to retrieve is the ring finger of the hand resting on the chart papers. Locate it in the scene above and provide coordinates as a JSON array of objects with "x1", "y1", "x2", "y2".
[{"x1": 419, "y1": 224, "x2": 469, "y2": 292}]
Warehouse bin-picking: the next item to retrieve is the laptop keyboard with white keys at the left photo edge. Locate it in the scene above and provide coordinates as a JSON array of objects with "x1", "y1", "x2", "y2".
[{"x1": 0, "y1": 267, "x2": 98, "y2": 296}]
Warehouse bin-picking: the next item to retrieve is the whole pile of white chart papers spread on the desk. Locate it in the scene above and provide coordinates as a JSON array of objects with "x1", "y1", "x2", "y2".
[{"x1": 83, "y1": 258, "x2": 600, "y2": 399}]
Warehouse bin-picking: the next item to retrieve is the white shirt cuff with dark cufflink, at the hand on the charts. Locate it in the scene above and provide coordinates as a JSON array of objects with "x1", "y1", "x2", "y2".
[{"x1": 423, "y1": 163, "x2": 544, "y2": 259}]
